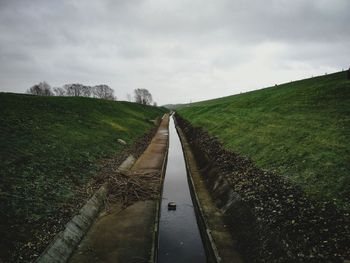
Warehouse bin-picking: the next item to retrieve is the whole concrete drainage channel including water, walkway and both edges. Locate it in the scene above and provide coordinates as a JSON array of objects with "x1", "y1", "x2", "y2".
[{"x1": 36, "y1": 117, "x2": 242, "y2": 263}]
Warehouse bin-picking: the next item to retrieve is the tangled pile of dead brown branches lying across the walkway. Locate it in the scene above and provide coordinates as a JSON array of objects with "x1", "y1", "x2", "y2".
[{"x1": 108, "y1": 172, "x2": 161, "y2": 207}]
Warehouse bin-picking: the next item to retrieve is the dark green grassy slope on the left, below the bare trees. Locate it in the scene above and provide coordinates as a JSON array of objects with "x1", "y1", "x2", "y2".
[{"x1": 0, "y1": 93, "x2": 165, "y2": 261}]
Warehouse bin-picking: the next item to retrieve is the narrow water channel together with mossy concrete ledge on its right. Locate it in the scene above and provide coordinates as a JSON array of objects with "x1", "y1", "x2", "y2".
[{"x1": 158, "y1": 115, "x2": 243, "y2": 263}]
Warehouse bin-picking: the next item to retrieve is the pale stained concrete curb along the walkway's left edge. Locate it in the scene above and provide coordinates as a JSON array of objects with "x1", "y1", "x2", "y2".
[{"x1": 35, "y1": 155, "x2": 136, "y2": 263}]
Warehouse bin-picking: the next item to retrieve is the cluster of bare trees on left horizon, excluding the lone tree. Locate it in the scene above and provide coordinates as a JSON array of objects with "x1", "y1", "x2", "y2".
[{"x1": 26, "y1": 81, "x2": 117, "y2": 100}]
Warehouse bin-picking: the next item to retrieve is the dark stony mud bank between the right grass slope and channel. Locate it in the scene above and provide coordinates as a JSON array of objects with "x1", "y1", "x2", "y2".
[{"x1": 176, "y1": 115, "x2": 350, "y2": 262}]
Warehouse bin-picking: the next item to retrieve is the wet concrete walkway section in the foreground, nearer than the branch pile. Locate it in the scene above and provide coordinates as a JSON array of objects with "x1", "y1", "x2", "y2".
[{"x1": 70, "y1": 201, "x2": 156, "y2": 263}]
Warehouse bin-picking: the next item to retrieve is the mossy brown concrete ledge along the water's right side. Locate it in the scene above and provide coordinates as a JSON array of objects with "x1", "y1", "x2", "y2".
[{"x1": 177, "y1": 117, "x2": 243, "y2": 263}]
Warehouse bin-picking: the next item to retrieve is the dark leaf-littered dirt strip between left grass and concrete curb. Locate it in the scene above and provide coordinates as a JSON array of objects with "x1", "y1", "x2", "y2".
[{"x1": 6, "y1": 120, "x2": 159, "y2": 262}]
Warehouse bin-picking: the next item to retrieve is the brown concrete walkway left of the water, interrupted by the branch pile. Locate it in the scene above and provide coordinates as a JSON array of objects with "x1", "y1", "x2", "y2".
[{"x1": 69, "y1": 115, "x2": 169, "y2": 263}]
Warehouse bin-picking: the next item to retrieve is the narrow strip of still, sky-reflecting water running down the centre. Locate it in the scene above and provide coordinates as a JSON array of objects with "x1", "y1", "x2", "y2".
[{"x1": 158, "y1": 118, "x2": 206, "y2": 263}]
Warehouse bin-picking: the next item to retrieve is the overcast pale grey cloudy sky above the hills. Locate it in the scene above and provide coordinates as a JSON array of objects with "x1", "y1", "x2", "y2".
[{"x1": 0, "y1": 0, "x2": 350, "y2": 104}]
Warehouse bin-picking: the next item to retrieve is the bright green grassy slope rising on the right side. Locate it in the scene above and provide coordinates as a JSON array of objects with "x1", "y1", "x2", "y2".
[{"x1": 178, "y1": 72, "x2": 350, "y2": 208}]
